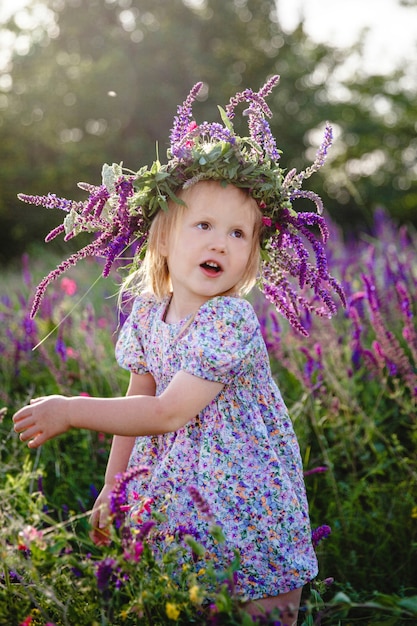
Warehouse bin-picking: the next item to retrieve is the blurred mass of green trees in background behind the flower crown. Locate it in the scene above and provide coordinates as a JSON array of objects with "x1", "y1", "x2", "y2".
[{"x1": 0, "y1": 0, "x2": 417, "y2": 262}]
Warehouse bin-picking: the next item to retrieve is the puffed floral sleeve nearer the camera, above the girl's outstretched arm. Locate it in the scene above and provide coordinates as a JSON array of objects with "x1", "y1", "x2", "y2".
[{"x1": 179, "y1": 296, "x2": 261, "y2": 385}]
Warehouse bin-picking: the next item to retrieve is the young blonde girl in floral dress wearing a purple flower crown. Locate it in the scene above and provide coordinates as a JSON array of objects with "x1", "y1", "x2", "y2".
[{"x1": 14, "y1": 77, "x2": 342, "y2": 624}]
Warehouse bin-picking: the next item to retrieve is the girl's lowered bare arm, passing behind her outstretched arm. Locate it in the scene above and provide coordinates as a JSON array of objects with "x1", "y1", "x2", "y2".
[{"x1": 90, "y1": 374, "x2": 155, "y2": 545}]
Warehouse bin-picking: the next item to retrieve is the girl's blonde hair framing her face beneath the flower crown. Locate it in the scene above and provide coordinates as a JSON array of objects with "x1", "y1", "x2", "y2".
[{"x1": 121, "y1": 180, "x2": 263, "y2": 300}]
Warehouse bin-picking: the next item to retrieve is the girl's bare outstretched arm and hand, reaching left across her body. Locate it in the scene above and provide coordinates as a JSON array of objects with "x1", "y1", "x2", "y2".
[{"x1": 13, "y1": 372, "x2": 223, "y2": 448}]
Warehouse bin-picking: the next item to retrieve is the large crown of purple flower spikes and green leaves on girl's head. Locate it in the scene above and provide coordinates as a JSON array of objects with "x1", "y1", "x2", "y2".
[{"x1": 18, "y1": 76, "x2": 345, "y2": 335}]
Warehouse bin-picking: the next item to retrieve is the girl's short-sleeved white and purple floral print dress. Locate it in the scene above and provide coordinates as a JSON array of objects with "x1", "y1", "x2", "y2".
[{"x1": 116, "y1": 294, "x2": 317, "y2": 599}]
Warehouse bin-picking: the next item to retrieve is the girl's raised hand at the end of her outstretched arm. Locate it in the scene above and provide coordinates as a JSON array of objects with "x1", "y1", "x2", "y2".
[{"x1": 13, "y1": 396, "x2": 71, "y2": 448}]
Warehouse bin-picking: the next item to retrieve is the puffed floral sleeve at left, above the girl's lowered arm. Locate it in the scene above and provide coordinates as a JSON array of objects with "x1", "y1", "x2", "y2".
[{"x1": 115, "y1": 295, "x2": 154, "y2": 374}]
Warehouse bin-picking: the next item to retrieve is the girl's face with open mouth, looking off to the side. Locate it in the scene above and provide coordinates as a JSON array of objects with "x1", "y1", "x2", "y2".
[{"x1": 161, "y1": 181, "x2": 259, "y2": 321}]
